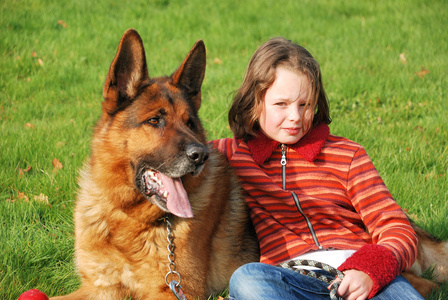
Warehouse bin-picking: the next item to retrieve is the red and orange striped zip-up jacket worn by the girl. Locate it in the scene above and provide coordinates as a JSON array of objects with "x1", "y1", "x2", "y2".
[{"x1": 212, "y1": 124, "x2": 417, "y2": 298}]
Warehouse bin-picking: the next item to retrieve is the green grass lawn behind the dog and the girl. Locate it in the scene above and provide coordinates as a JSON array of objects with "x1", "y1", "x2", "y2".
[{"x1": 0, "y1": 0, "x2": 448, "y2": 299}]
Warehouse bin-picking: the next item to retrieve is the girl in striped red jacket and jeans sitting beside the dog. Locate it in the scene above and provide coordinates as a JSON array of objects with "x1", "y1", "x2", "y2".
[{"x1": 213, "y1": 38, "x2": 423, "y2": 300}]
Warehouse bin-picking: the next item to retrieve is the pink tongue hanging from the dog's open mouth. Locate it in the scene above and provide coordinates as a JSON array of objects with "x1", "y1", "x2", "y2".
[{"x1": 157, "y1": 173, "x2": 193, "y2": 218}]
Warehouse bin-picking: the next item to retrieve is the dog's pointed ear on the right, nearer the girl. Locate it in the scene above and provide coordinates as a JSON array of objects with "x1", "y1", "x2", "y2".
[{"x1": 171, "y1": 40, "x2": 206, "y2": 111}]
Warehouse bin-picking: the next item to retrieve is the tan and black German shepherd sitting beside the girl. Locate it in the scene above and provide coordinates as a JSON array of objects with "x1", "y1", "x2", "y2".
[{"x1": 53, "y1": 29, "x2": 448, "y2": 300}]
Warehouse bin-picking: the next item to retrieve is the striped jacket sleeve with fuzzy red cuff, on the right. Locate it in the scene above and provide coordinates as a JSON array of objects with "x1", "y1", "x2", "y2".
[{"x1": 339, "y1": 146, "x2": 417, "y2": 298}]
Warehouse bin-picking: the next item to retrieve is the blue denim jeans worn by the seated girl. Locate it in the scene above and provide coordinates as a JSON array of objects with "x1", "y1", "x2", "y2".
[{"x1": 229, "y1": 263, "x2": 424, "y2": 300}]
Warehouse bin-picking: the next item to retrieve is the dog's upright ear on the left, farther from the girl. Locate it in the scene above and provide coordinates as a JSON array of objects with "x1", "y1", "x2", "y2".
[{"x1": 103, "y1": 29, "x2": 149, "y2": 115}]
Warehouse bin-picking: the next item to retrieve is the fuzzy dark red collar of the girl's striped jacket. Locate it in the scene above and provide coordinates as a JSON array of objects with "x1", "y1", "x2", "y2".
[{"x1": 247, "y1": 123, "x2": 330, "y2": 165}]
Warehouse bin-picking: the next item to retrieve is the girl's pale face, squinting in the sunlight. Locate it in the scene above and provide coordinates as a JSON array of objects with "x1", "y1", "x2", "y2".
[{"x1": 258, "y1": 66, "x2": 314, "y2": 144}]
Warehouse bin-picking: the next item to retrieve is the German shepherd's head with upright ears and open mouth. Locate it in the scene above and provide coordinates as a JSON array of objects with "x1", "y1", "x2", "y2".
[{"x1": 96, "y1": 29, "x2": 208, "y2": 217}]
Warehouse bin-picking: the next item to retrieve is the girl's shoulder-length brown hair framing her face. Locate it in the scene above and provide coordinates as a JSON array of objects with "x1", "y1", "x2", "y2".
[{"x1": 229, "y1": 37, "x2": 331, "y2": 140}]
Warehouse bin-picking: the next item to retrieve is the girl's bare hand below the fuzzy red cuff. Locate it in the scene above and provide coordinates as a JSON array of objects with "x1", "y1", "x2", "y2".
[{"x1": 328, "y1": 270, "x2": 373, "y2": 300}]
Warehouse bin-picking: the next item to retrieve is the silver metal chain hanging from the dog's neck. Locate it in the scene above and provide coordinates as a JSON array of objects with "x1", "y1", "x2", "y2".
[{"x1": 162, "y1": 215, "x2": 187, "y2": 300}]
